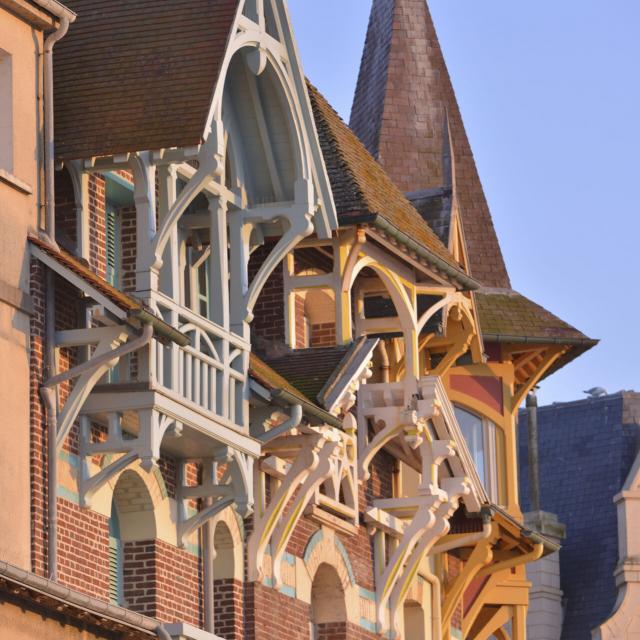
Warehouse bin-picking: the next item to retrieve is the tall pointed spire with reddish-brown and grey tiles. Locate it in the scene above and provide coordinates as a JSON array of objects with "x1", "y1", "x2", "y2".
[{"x1": 350, "y1": 0, "x2": 510, "y2": 288}]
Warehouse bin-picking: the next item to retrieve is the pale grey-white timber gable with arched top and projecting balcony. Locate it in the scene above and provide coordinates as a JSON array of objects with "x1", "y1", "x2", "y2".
[{"x1": 43, "y1": 0, "x2": 337, "y2": 544}]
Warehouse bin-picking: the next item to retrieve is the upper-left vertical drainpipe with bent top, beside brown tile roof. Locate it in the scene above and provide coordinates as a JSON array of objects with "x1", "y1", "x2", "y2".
[{"x1": 35, "y1": 0, "x2": 76, "y2": 244}]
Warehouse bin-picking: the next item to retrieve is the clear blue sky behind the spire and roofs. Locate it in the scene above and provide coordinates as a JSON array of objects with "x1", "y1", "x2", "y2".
[{"x1": 289, "y1": 0, "x2": 640, "y2": 404}]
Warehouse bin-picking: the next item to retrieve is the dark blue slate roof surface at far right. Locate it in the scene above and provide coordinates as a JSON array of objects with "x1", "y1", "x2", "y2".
[{"x1": 517, "y1": 396, "x2": 640, "y2": 640}]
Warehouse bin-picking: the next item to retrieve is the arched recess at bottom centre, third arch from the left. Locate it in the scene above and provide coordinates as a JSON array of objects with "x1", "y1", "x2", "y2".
[{"x1": 311, "y1": 564, "x2": 347, "y2": 640}]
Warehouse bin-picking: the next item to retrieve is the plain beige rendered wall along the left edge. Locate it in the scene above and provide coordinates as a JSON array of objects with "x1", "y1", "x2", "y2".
[{"x1": 0, "y1": 8, "x2": 44, "y2": 568}]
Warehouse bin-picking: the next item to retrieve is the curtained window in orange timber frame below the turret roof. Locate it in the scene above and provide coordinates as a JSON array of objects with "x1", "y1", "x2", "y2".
[{"x1": 454, "y1": 406, "x2": 506, "y2": 505}]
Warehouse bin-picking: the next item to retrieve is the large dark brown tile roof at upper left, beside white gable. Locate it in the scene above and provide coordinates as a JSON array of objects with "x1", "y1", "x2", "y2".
[{"x1": 54, "y1": 0, "x2": 238, "y2": 159}]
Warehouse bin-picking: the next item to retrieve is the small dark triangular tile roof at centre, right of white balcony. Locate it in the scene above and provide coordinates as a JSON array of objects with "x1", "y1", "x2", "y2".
[{"x1": 254, "y1": 345, "x2": 351, "y2": 404}]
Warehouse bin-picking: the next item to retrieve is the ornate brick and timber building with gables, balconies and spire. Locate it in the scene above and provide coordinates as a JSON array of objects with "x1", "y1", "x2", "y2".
[{"x1": 0, "y1": 0, "x2": 595, "y2": 640}]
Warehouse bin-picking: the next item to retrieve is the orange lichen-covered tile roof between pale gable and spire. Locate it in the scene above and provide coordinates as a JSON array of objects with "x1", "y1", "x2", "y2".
[{"x1": 308, "y1": 83, "x2": 461, "y2": 271}]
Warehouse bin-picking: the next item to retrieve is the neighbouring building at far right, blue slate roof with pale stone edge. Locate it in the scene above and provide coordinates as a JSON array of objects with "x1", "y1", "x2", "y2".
[{"x1": 519, "y1": 392, "x2": 640, "y2": 640}]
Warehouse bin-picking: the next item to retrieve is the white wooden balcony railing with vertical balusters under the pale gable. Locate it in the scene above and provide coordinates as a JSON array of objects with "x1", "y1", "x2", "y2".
[{"x1": 149, "y1": 293, "x2": 250, "y2": 428}]
